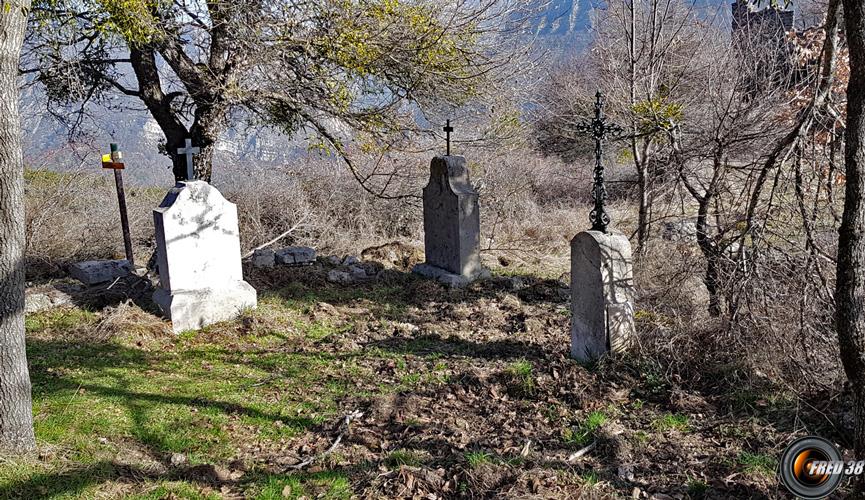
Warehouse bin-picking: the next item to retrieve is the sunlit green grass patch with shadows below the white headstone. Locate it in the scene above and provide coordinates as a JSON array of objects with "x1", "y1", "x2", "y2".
[{"x1": 0, "y1": 303, "x2": 410, "y2": 499}]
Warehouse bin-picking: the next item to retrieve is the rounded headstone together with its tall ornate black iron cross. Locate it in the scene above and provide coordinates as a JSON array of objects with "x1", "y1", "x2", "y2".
[{"x1": 571, "y1": 90, "x2": 636, "y2": 361}]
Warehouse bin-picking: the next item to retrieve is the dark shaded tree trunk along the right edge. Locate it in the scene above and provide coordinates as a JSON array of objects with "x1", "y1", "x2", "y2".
[{"x1": 835, "y1": 0, "x2": 865, "y2": 464}]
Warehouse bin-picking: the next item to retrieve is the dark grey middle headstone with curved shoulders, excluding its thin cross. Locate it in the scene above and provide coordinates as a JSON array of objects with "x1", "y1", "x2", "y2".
[{"x1": 413, "y1": 156, "x2": 489, "y2": 286}]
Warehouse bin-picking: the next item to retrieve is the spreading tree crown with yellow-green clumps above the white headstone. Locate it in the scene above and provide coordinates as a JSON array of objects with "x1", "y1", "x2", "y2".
[{"x1": 23, "y1": 0, "x2": 519, "y2": 180}]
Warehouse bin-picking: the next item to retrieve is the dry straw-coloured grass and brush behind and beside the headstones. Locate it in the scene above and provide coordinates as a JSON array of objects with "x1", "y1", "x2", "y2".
[{"x1": 27, "y1": 145, "x2": 842, "y2": 418}]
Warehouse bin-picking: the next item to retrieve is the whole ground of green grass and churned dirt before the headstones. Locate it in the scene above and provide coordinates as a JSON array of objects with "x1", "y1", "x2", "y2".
[{"x1": 10, "y1": 264, "x2": 825, "y2": 498}]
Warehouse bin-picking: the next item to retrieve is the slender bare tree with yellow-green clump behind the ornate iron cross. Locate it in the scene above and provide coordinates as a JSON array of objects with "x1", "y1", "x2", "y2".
[{"x1": 537, "y1": 0, "x2": 714, "y2": 254}]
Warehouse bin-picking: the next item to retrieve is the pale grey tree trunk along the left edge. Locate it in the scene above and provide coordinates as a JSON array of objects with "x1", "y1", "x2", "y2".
[{"x1": 0, "y1": 0, "x2": 36, "y2": 454}]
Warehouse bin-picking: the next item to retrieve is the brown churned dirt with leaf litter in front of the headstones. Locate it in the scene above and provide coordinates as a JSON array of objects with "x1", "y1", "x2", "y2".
[{"x1": 13, "y1": 254, "x2": 844, "y2": 500}]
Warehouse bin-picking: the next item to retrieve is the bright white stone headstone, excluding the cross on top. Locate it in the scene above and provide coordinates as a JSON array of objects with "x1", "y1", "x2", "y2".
[{"x1": 153, "y1": 181, "x2": 257, "y2": 332}]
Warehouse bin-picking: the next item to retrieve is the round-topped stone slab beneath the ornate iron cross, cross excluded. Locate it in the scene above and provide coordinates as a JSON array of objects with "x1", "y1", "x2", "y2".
[{"x1": 571, "y1": 231, "x2": 636, "y2": 361}]
